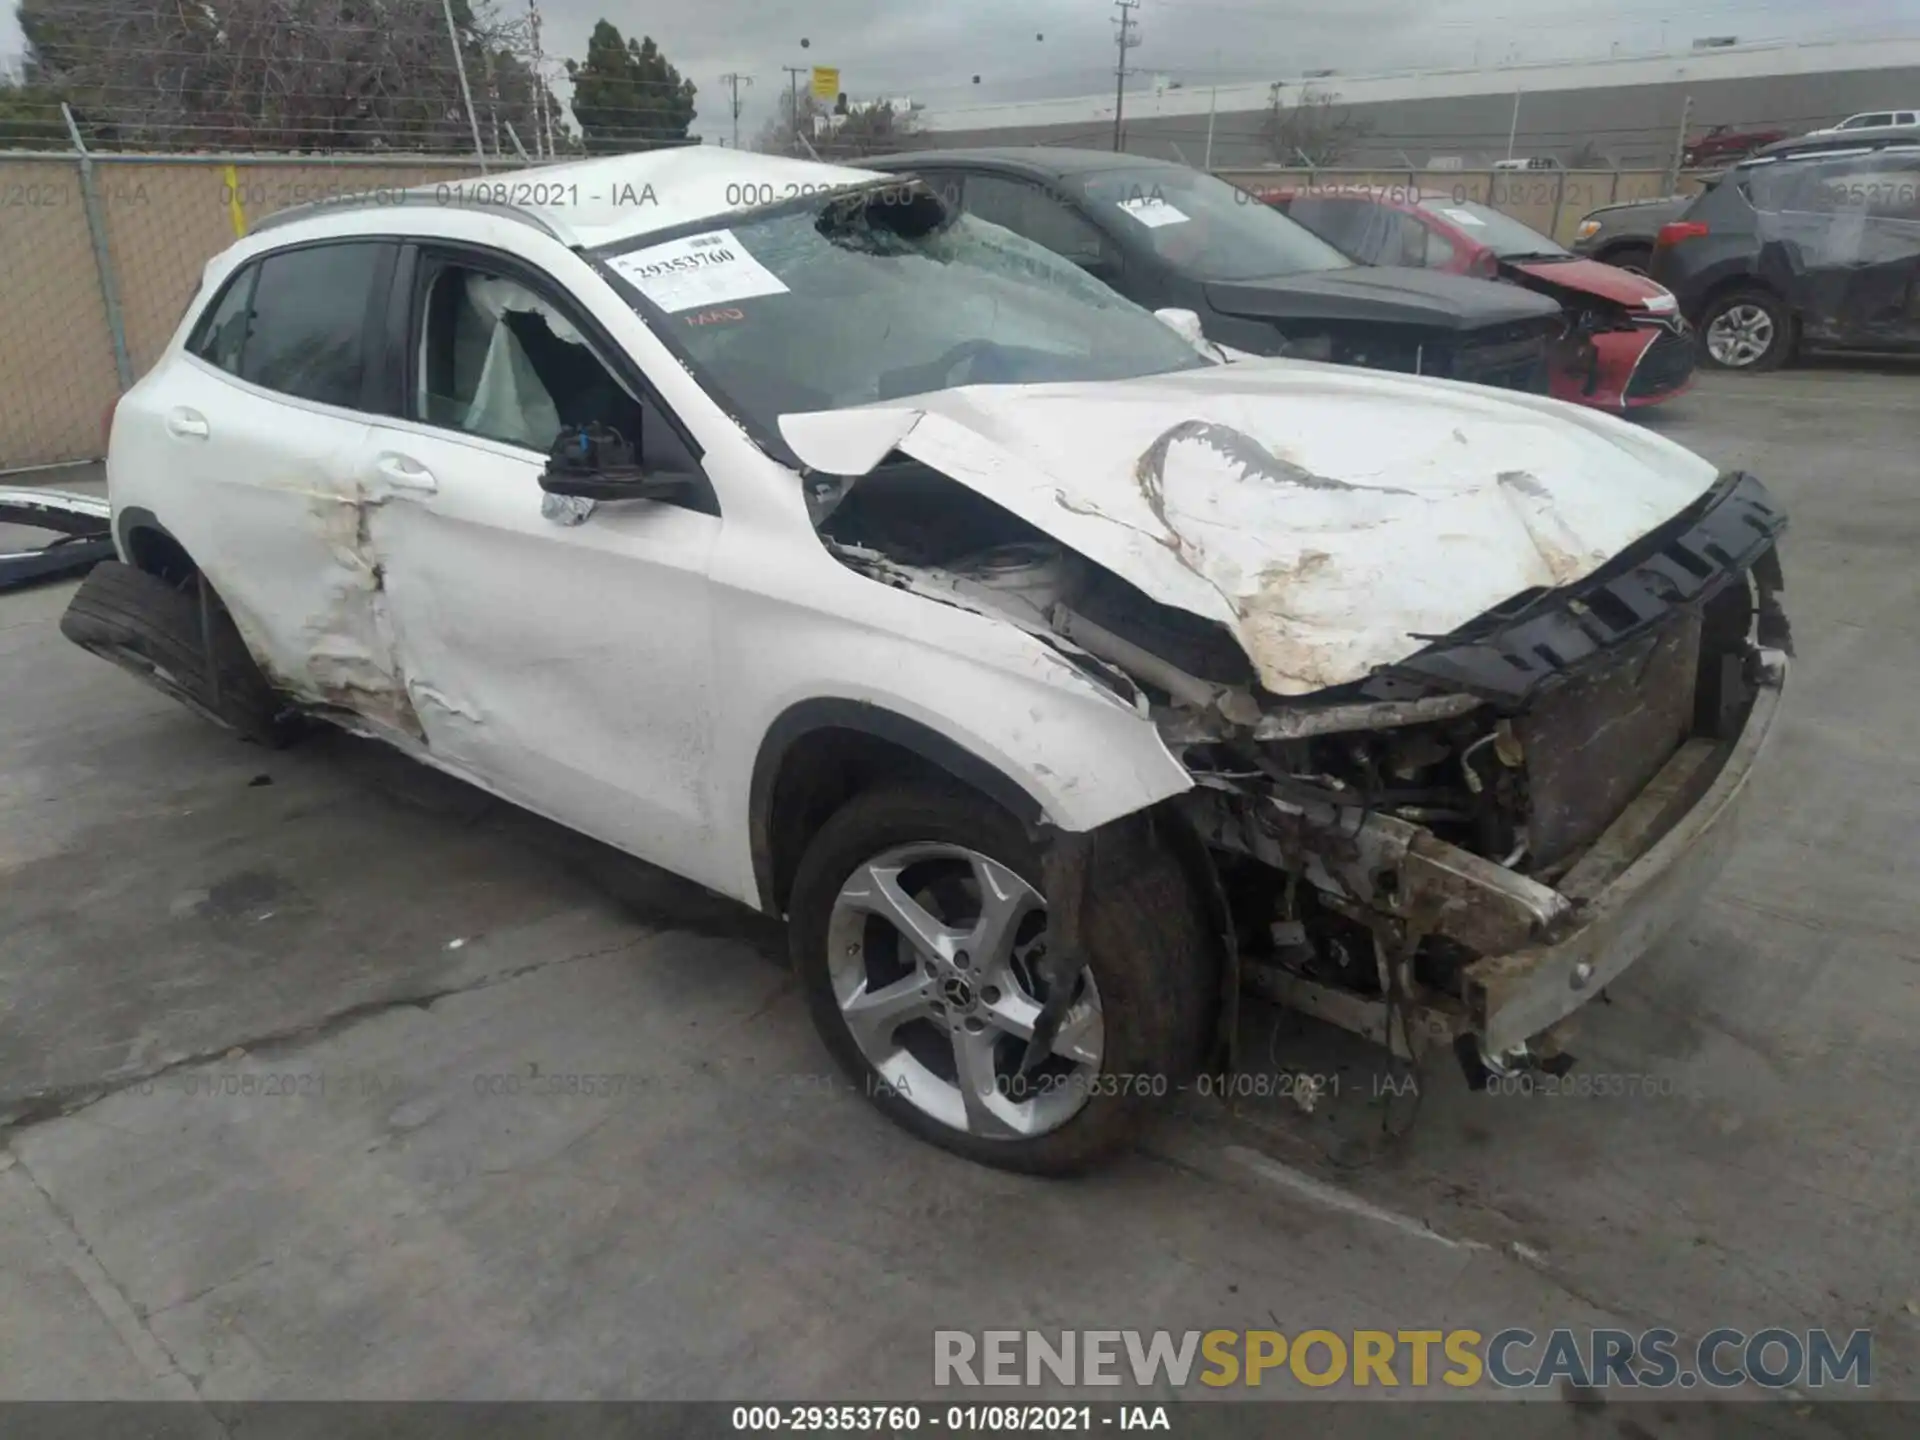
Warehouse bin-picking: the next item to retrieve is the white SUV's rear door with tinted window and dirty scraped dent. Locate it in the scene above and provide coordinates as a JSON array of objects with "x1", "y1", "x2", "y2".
[{"x1": 133, "y1": 240, "x2": 407, "y2": 733}]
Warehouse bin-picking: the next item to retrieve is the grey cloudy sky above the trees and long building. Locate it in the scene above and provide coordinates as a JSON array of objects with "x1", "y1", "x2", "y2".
[{"x1": 0, "y1": 0, "x2": 1920, "y2": 138}]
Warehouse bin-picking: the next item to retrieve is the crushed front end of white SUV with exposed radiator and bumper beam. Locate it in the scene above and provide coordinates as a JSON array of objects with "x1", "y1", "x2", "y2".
[{"x1": 1144, "y1": 474, "x2": 1791, "y2": 1075}]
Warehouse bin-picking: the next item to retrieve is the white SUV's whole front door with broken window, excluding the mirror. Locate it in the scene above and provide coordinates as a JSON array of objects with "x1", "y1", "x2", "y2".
[{"x1": 361, "y1": 246, "x2": 724, "y2": 877}]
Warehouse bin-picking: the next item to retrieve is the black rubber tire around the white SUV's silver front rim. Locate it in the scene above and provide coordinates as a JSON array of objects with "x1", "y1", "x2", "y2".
[{"x1": 789, "y1": 785, "x2": 1221, "y2": 1175}]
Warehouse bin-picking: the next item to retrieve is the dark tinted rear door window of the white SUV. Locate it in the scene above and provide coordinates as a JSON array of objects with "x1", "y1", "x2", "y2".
[{"x1": 238, "y1": 240, "x2": 394, "y2": 409}]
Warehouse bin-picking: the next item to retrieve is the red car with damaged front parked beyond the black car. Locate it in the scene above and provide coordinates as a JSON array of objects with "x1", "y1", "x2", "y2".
[{"x1": 1261, "y1": 188, "x2": 1695, "y2": 411}]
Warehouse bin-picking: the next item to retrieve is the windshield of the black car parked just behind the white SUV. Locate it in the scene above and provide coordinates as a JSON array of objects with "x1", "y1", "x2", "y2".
[{"x1": 1079, "y1": 165, "x2": 1354, "y2": 280}]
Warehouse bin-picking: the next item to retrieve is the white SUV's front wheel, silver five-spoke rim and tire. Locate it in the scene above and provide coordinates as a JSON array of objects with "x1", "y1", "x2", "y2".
[{"x1": 791, "y1": 785, "x2": 1219, "y2": 1175}]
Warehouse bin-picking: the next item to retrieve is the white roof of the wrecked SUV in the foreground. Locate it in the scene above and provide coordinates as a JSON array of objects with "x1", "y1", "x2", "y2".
[{"x1": 253, "y1": 146, "x2": 887, "y2": 250}]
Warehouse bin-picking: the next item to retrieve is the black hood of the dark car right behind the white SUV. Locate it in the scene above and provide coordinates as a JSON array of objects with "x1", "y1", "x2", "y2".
[{"x1": 1204, "y1": 265, "x2": 1559, "y2": 330}]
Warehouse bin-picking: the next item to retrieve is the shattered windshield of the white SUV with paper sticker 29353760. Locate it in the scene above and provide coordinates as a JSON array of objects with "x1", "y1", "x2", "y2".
[{"x1": 601, "y1": 182, "x2": 1210, "y2": 432}]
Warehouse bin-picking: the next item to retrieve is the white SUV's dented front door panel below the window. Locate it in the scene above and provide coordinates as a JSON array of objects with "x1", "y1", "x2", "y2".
[{"x1": 363, "y1": 424, "x2": 720, "y2": 879}]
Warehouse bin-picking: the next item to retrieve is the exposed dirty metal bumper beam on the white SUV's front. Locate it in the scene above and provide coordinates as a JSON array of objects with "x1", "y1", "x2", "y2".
[{"x1": 1185, "y1": 647, "x2": 1788, "y2": 1064}]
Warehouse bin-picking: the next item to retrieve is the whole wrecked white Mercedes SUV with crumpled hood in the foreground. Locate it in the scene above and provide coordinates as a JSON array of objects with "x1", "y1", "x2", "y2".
[{"x1": 63, "y1": 148, "x2": 1789, "y2": 1173}]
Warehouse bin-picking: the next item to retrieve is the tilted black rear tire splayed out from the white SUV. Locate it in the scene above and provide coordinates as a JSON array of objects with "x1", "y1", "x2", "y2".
[{"x1": 60, "y1": 561, "x2": 292, "y2": 745}]
